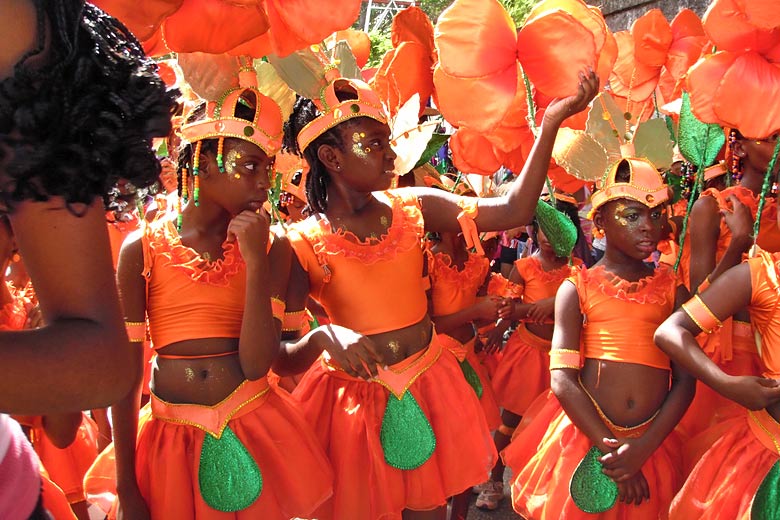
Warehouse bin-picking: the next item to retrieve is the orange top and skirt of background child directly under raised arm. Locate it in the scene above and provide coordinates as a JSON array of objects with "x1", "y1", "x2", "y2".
[{"x1": 428, "y1": 248, "x2": 501, "y2": 430}]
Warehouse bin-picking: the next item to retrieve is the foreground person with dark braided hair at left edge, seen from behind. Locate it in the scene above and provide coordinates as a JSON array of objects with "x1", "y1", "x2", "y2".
[{"x1": 0, "y1": 0, "x2": 175, "y2": 519}]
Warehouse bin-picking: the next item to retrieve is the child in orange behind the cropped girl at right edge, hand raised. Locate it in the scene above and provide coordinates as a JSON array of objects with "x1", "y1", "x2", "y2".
[{"x1": 681, "y1": 130, "x2": 780, "y2": 440}]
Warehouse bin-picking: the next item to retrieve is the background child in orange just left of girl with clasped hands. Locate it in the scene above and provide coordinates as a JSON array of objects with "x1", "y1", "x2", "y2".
[{"x1": 477, "y1": 202, "x2": 582, "y2": 509}]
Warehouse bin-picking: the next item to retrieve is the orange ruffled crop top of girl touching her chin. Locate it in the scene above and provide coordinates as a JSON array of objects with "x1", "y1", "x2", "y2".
[{"x1": 141, "y1": 213, "x2": 273, "y2": 349}]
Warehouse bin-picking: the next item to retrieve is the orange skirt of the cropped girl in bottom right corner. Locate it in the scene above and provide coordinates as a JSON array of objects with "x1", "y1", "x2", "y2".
[{"x1": 669, "y1": 409, "x2": 780, "y2": 520}]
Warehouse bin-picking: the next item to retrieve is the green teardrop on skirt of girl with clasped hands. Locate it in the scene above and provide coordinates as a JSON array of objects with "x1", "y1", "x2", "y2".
[{"x1": 569, "y1": 446, "x2": 618, "y2": 513}]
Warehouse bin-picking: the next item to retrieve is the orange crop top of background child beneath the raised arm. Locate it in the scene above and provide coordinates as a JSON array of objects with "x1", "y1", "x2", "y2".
[{"x1": 429, "y1": 253, "x2": 490, "y2": 316}]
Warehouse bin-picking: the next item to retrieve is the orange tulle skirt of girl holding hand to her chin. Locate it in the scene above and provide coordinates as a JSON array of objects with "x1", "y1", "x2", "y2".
[{"x1": 85, "y1": 378, "x2": 333, "y2": 520}]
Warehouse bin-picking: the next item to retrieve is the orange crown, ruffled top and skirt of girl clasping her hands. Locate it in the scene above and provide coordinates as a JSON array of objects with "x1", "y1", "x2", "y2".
[{"x1": 502, "y1": 158, "x2": 682, "y2": 520}]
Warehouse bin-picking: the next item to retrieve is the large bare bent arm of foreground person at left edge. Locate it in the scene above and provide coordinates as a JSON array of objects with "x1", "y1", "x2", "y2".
[{"x1": 0, "y1": 198, "x2": 138, "y2": 415}]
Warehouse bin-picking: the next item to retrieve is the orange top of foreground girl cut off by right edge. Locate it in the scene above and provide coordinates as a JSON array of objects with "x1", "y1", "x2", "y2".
[{"x1": 747, "y1": 251, "x2": 780, "y2": 379}]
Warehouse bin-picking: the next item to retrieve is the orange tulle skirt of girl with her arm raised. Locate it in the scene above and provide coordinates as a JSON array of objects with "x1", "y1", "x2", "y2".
[{"x1": 293, "y1": 338, "x2": 496, "y2": 520}]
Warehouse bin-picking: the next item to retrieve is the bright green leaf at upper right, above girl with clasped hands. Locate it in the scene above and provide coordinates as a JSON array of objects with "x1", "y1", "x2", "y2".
[{"x1": 678, "y1": 92, "x2": 726, "y2": 169}]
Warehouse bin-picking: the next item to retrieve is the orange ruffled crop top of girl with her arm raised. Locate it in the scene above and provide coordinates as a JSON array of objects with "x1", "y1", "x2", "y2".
[{"x1": 287, "y1": 190, "x2": 428, "y2": 335}]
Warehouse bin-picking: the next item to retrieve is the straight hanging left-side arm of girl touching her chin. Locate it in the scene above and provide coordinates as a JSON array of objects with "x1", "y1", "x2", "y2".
[{"x1": 111, "y1": 232, "x2": 149, "y2": 519}]
